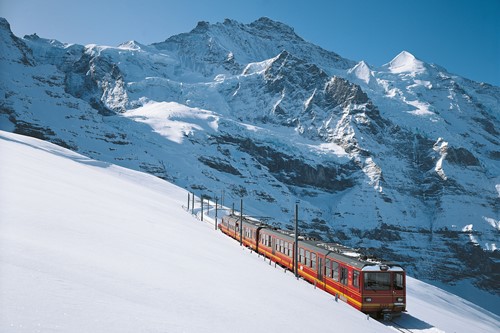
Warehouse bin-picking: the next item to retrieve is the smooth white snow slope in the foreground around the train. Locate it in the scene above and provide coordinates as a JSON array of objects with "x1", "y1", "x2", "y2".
[{"x1": 0, "y1": 131, "x2": 500, "y2": 332}]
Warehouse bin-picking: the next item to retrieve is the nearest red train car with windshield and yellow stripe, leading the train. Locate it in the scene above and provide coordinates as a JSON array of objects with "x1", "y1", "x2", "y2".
[{"x1": 298, "y1": 241, "x2": 406, "y2": 318}]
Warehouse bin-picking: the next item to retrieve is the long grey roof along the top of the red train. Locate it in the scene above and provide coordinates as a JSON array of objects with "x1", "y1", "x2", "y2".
[{"x1": 225, "y1": 215, "x2": 403, "y2": 271}]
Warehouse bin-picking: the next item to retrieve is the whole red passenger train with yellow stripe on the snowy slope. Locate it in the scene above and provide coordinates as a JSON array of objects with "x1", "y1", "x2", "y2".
[{"x1": 219, "y1": 215, "x2": 406, "y2": 318}]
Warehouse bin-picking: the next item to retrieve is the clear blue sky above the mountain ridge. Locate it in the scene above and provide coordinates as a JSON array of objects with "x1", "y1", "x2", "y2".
[{"x1": 0, "y1": 0, "x2": 500, "y2": 86}]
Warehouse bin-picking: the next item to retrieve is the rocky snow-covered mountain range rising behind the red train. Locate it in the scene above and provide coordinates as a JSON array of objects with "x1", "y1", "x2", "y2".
[{"x1": 0, "y1": 18, "x2": 500, "y2": 313}]
